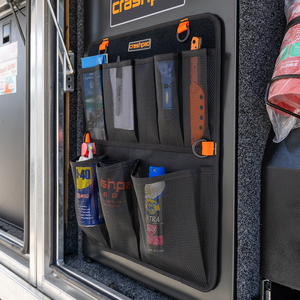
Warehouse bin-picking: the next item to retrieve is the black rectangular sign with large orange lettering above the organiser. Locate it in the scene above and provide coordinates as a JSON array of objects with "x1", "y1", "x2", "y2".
[{"x1": 110, "y1": 0, "x2": 186, "y2": 27}]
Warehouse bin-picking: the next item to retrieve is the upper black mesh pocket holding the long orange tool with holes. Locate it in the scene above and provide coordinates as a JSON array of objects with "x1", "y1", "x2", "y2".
[{"x1": 182, "y1": 49, "x2": 213, "y2": 147}]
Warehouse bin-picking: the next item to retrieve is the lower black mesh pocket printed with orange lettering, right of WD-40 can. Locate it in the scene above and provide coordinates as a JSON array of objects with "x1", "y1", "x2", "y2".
[{"x1": 97, "y1": 160, "x2": 139, "y2": 259}]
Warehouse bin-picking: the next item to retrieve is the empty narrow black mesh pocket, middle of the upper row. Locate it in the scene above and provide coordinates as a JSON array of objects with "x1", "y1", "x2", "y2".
[{"x1": 134, "y1": 57, "x2": 159, "y2": 144}]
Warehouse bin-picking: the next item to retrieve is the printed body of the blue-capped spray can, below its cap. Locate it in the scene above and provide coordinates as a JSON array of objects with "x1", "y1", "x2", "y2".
[{"x1": 145, "y1": 181, "x2": 166, "y2": 252}]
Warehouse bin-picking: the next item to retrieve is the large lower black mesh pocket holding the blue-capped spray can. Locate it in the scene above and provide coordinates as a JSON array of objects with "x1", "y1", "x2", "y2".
[{"x1": 132, "y1": 166, "x2": 212, "y2": 287}]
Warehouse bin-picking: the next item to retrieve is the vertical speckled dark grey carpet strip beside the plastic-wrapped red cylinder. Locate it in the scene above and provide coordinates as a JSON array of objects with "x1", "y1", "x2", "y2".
[{"x1": 236, "y1": 0, "x2": 285, "y2": 300}]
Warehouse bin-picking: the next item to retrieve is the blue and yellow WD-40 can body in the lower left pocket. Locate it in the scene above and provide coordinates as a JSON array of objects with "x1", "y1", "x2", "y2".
[{"x1": 76, "y1": 165, "x2": 104, "y2": 226}]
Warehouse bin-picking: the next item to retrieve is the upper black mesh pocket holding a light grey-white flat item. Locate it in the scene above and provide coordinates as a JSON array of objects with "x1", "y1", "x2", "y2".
[{"x1": 103, "y1": 60, "x2": 137, "y2": 142}]
